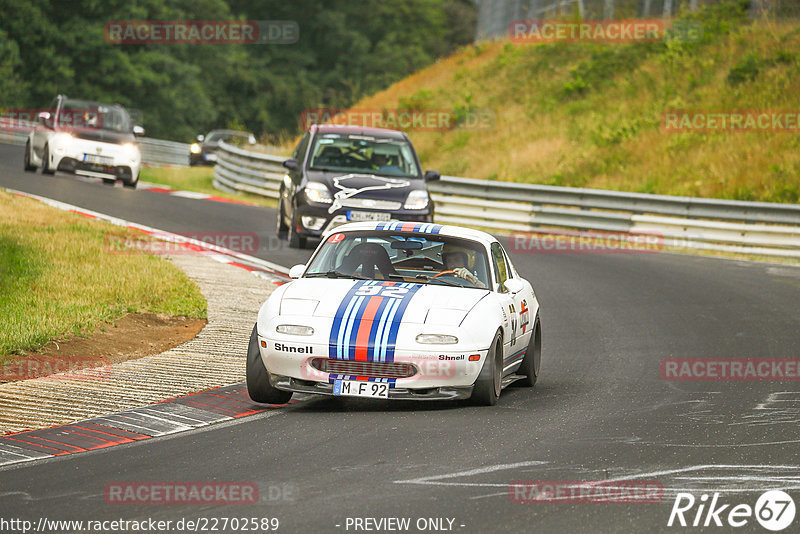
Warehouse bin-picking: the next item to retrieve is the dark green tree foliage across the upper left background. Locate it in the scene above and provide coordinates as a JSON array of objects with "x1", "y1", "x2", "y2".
[{"x1": 0, "y1": 0, "x2": 476, "y2": 141}]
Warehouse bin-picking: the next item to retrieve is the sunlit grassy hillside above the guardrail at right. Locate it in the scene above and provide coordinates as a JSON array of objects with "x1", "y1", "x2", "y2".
[{"x1": 354, "y1": 4, "x2": 800, "y2": 202}]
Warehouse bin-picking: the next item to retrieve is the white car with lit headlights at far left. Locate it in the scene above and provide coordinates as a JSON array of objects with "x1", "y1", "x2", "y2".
[{"x1": 24, "y1": 95, "x2": 144, "y2": 188}]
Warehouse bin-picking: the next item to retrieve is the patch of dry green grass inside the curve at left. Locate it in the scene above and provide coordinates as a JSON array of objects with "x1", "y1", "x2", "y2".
[{"x1": 0, "y1": 192, "x2": 206, "y2": 363}]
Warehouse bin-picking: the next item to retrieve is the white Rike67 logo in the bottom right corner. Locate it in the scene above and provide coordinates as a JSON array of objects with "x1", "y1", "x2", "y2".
[{"x1": 667, "y1": 490, "x2": 795, "y2": 532}]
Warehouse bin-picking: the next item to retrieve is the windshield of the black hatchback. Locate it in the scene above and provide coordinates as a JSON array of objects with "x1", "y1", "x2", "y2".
[{"x1": 309, "y1": 133, "x2": 420, "y2": 178}]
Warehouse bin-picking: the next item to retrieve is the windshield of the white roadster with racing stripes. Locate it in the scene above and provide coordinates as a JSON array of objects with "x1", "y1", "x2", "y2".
[{"x1": 305, "y1": 231, "x2": 489, "y2": 288}]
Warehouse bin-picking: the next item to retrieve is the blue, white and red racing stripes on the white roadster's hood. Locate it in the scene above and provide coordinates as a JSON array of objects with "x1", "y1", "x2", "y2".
[{"x1": 328, "y1": 280, "x2": 422, "y2": 362}]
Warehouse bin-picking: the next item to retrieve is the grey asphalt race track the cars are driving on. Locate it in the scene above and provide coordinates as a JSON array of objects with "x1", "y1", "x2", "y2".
[{"x1": 0, "y1": 145, "x2": 800, "y2": 533}]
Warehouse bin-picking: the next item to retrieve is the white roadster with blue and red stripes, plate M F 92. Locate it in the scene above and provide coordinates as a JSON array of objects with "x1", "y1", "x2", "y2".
[{"x1": 247, "y1": 222, "x2": 541, "y2": 405}]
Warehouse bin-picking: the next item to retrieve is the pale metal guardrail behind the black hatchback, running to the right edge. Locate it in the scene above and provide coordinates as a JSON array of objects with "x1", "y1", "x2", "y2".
[{"x1": 214, "y1": 144, "x2": 800, "y2": 258}]
